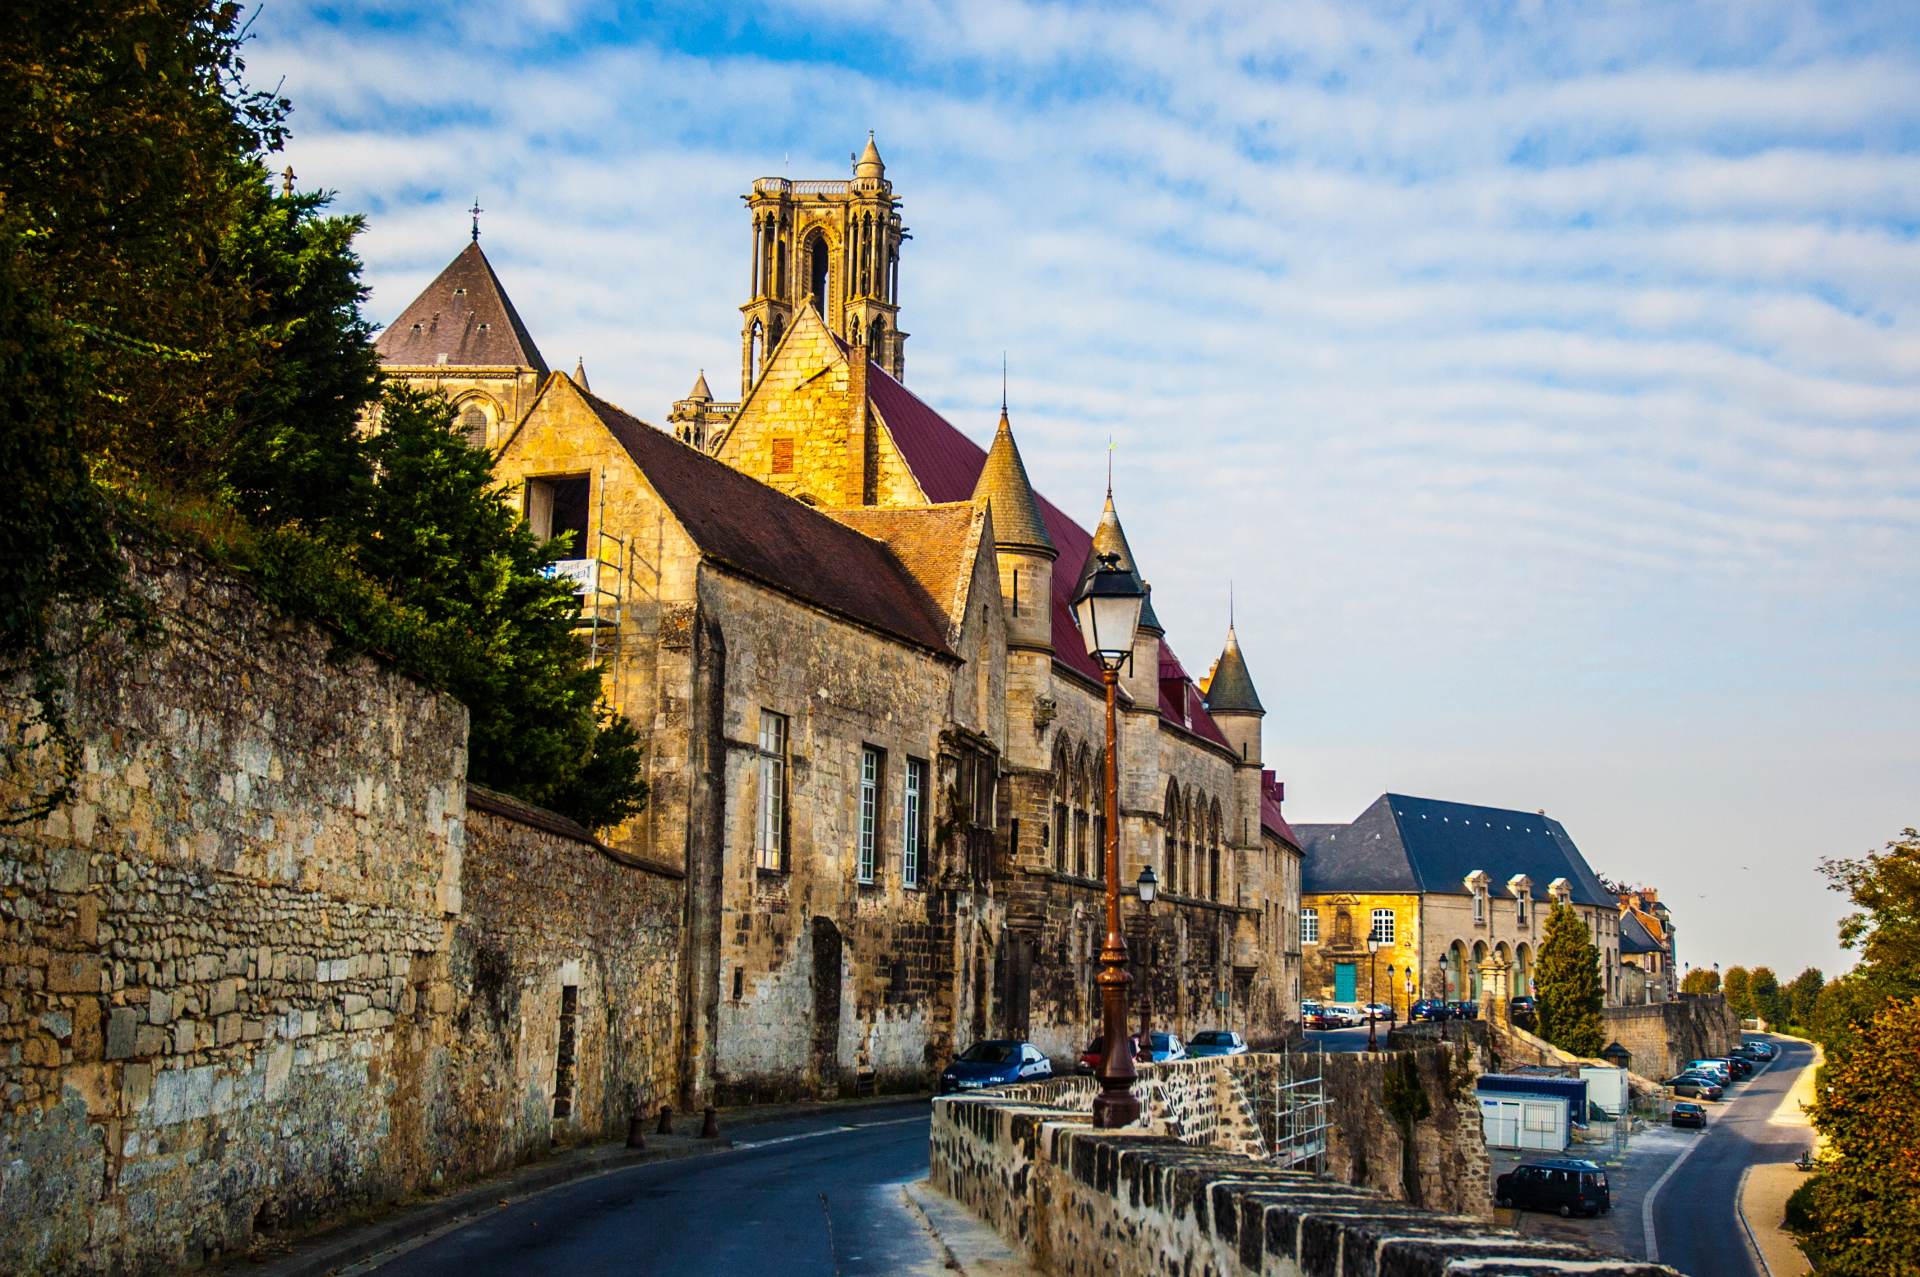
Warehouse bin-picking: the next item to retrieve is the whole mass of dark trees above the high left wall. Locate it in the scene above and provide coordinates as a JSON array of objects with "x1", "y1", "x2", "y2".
[{"x1": 0, "y1": 0, "x2": 647, "y2": 828}]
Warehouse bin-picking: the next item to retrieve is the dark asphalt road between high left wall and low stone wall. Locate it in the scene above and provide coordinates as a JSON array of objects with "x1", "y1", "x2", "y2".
[{"x1": 362, "y1": 1100, "x2": 945, "y2": 1277}]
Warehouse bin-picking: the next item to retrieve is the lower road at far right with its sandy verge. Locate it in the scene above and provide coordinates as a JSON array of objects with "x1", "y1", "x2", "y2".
[{"x1": 1647, "y1": 1039, "x2": 1812, "y2": 1277}]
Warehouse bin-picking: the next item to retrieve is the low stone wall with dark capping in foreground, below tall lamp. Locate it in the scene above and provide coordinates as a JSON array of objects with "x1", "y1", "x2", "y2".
[{"x1": 931, "y1": 1095, "x2": 1674, "y2": 1277}]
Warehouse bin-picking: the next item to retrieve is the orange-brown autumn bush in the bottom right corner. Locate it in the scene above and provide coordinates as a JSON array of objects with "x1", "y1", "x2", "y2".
[{"x1": 1809, "y1": 999, "x2": 1920, "y2": 1277}]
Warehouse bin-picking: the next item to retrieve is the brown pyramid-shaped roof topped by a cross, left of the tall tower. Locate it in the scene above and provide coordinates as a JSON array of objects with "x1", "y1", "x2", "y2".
[{"x1": 374, "y1": 240, "x2": 547, "y2": 376}]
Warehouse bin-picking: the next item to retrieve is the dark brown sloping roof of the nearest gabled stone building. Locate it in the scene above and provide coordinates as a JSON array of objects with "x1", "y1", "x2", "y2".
[{"x1": 572, "y1": 378, "x2": 952, "y2": 657}]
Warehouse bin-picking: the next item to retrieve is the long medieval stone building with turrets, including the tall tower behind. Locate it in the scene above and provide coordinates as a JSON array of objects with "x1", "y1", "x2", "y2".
[{"x1": 388, "y1": 142, "x2": 1300, "y2": 1098}]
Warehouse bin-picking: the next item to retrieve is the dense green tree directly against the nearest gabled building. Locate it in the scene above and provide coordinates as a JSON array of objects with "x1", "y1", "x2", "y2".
[{"x1": 353, "y1": 386, "x2": 647, "y2": 828}]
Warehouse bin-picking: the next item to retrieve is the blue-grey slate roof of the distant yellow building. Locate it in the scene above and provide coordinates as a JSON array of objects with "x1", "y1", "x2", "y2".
[{"x1": 1296, "y1": 793, "x2": 1619, "y2": 908}]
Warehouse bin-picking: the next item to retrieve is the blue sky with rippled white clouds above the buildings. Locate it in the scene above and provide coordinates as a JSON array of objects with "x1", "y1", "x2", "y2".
[{"x1": 248, "y1": 0, "x2": 1920, "y2": 977}]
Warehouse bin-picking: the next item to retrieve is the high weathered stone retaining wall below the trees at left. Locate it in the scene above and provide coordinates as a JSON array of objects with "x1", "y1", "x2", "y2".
[{"x1": 0, "y1": 549, "x2": 680, "y2": 1273}]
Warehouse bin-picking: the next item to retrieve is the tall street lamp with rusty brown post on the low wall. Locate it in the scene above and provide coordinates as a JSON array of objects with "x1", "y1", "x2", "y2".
[{"x1": 1073, "y1": 555, "x2": 1146, "y2": 1131}]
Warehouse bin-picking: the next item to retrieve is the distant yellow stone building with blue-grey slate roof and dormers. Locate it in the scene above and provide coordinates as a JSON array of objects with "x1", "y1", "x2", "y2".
[{"x1": 1298, "y1": 793, "x2": 1626, "y2": 1016}]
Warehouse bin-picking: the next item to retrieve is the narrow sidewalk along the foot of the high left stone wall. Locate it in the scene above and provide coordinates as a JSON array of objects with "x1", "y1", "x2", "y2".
[{"x1": 221, "y1": 1095, "x2": 929, "y2": 1277}]
